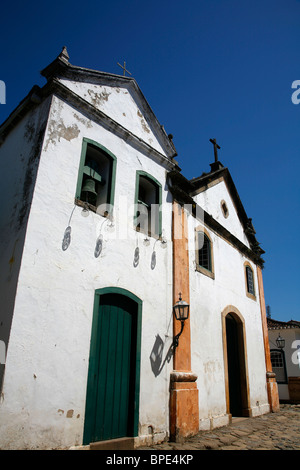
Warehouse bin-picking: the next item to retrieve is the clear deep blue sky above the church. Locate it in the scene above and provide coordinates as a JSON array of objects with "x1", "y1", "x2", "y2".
[{"x1": 0, "y1": 0, "x2": 300, "y2": 321}]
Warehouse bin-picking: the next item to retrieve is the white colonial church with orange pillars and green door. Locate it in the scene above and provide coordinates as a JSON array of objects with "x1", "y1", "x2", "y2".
[{"x1": 0, "y1": 48, "x2": 279, "y2": 449}]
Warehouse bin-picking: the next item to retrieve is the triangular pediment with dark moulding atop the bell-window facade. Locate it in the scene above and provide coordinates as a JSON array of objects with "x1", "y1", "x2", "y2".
[{"x1": 41, "y1": 50, "x2": 176, "y2": 159}]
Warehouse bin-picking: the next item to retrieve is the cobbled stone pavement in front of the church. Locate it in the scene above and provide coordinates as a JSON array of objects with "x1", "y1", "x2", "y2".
[{"x1": 137, "y1": 405, "x2": 300, "y2": 451}]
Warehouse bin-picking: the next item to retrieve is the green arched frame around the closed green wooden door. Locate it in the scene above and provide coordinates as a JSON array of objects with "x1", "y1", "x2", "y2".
[{"x1": 83, "y1": 287, "x2": 143, "y2": 445}]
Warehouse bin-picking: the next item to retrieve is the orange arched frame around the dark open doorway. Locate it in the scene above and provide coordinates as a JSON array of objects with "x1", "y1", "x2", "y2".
[{"x1": 222, "y1": 305, "x2": 252, "y2": 417}]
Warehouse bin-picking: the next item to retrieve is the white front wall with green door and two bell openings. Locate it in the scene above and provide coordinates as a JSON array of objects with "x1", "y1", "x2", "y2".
[{"x1": 0, "y1": 97, "x2": 172, "y2": 448}]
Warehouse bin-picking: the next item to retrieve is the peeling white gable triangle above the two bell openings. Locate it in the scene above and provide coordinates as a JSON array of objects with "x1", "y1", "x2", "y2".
[{"x1": 59, "y1": 78, "x2": 167, "y2": 156}]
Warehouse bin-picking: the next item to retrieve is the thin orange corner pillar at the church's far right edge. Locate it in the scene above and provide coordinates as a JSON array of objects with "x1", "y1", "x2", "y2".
[{"x1": 257, "y1": 266, "x2": 280, "y2": 412}]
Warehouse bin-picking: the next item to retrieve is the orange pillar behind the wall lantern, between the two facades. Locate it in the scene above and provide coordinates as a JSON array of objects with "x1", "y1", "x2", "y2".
[{"x1": 170, "y1": 201, "x2": 199, "y2": 441}]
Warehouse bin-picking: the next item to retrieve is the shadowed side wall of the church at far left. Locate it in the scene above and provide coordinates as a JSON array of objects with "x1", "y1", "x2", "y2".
[{"x1": 0, "y1": 100, "x2": 49, "y2": 389}]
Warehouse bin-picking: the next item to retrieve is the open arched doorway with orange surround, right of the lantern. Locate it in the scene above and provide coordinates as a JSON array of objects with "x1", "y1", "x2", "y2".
[{"x1": 222, "y1": 306, "x2": 251, "y2": 417}]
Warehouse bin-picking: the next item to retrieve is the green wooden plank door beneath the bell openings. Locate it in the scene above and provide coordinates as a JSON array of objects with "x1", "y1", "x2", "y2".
[{"x1": 86, "y1": 294, "x2": 137, "y2": 442}]
